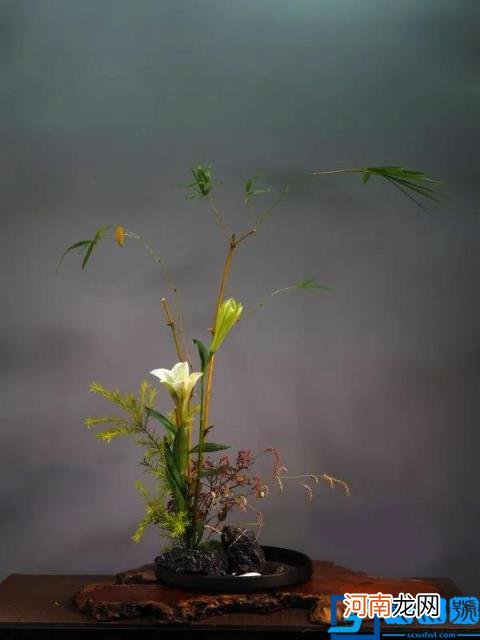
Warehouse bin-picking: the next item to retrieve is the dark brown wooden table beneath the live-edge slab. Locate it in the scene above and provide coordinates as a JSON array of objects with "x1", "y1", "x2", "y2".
[{"x1": 0, "y1": 574, "x2": 471, "y2": 640}]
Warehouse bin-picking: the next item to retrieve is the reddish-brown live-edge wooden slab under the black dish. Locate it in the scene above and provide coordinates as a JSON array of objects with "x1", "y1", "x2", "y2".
[{"x1": 73, "y1": 561, "x2": 455, "y2": 624}]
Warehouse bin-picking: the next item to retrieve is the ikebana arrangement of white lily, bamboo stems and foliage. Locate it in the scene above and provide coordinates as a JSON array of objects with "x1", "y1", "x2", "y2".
[{"x1": 61, "y1": 166, "x2": 440, "y2": 574}]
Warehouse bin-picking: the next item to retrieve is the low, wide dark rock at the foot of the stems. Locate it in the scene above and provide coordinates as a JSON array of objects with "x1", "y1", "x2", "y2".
[{"x1": 155, "y1": 547, "x2": 228, "y2": 578}]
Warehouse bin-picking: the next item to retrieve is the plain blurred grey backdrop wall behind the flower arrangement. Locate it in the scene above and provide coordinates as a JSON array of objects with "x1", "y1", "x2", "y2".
[{"x1": 0, "y1": 0, "x2": 480, "y2": 591}]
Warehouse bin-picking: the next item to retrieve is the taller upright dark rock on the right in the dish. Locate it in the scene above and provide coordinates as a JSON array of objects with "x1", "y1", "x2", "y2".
[{"x1": 222, "y1": 525, "x2": 265, "y2": 574}]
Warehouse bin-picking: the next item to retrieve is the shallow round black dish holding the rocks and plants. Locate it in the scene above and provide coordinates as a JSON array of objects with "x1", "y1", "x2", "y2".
[{"x1": 156, "y1": 546, "x2": 313, "y2": 593}]
